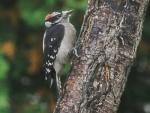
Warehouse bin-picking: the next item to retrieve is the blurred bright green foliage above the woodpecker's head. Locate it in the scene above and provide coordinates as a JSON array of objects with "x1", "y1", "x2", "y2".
[{"x1": 18, "y1": 0, "x2": 87, "y2": 27}]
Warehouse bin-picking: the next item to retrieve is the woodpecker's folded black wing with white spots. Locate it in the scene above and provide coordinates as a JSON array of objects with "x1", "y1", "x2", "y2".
[{"x1": 43, "y1": 24, "x2": 64, "y2": 85}]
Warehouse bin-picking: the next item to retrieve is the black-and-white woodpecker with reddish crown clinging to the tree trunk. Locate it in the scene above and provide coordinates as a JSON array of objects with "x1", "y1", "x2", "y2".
[{"x1": 43, "y1": 10, "x2": 76, "y2": 94}]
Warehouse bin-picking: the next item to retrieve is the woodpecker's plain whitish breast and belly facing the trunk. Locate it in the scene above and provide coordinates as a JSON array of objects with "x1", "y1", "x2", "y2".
[{"x1": 56, "y1": 23, "x2": 76, "y2": 64}]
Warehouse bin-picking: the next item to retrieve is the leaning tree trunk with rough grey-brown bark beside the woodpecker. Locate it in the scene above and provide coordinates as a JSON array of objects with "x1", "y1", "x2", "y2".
[{"x1": 55, "y1": 0, "x2": 149, "y2": 113}]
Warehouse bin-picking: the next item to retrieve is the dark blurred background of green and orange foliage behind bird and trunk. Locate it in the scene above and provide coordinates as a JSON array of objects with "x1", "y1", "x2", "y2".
[{"x1": 0, "y1": 0, "x2": 150, "y2": 113}]
